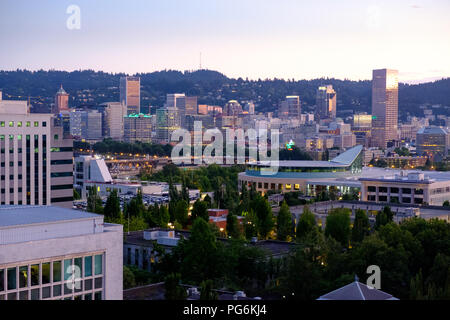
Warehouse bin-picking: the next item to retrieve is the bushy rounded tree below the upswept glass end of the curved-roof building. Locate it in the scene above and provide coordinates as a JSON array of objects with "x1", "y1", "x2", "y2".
[{"x1": 325, "y1": 208, "x2": 350, "y2": 247}]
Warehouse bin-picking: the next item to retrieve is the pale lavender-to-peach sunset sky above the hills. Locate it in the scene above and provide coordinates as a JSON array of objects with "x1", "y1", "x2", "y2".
[{"x1": 0, "y1": 0, "x2": 450, "y2": 81}]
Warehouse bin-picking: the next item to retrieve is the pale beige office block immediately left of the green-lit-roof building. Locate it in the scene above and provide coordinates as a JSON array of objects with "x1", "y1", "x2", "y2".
[{"x1": 100, "y1": 102, "x2": 127, "y2": 140}]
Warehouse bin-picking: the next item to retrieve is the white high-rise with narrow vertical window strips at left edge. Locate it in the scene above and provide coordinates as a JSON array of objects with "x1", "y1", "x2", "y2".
[{"x1": 0, "y1": 96, "x2": 73, "y2": 207}]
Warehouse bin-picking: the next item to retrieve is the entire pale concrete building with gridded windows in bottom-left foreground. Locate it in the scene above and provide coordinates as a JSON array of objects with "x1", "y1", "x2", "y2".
[{"x1": 0, "y1": 206, "x2": 123, "y2": 300}]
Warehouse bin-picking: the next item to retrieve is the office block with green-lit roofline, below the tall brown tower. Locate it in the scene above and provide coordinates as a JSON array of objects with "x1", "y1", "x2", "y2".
[{"x1": 124, "y1": 113, "x2": 152, "y2": 143}]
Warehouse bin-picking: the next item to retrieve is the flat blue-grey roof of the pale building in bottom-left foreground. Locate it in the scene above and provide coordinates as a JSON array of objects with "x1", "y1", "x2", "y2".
[{"x1": 0, "y1": 205, "x2": 102, "y2": 228}]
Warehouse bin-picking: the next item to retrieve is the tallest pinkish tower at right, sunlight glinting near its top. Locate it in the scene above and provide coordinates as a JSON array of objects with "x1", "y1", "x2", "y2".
[{"x1": 371, "y1": 69, "x2": 398, "y2": 149}]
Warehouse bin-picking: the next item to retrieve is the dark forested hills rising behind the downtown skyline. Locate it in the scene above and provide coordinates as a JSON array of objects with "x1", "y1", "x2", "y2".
[{"x1": 0, "y1": 70, "x2": 450, "y2": 117}]
